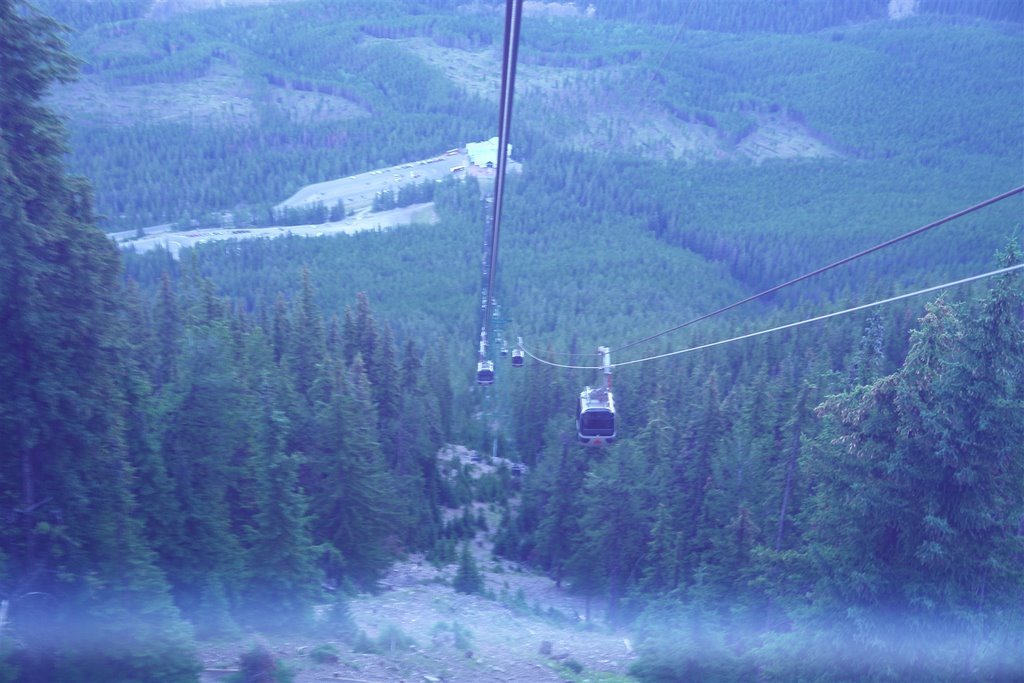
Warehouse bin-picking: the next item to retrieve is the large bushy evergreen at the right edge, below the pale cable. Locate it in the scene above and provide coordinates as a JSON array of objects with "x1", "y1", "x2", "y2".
[{"x1": 810, "y1": 264, "x2": 1024, "y2": 679}]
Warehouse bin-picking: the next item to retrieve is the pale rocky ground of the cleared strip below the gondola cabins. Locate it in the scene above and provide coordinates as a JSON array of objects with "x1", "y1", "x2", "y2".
[{"x1": 195, "y1": 446, "x2": 634, "y2": 683}]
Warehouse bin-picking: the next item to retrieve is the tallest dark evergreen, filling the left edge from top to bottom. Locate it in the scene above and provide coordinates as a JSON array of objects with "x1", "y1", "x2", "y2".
[{"x1": 0, "y1": 0, "x2": 197, "y2": 682}]
